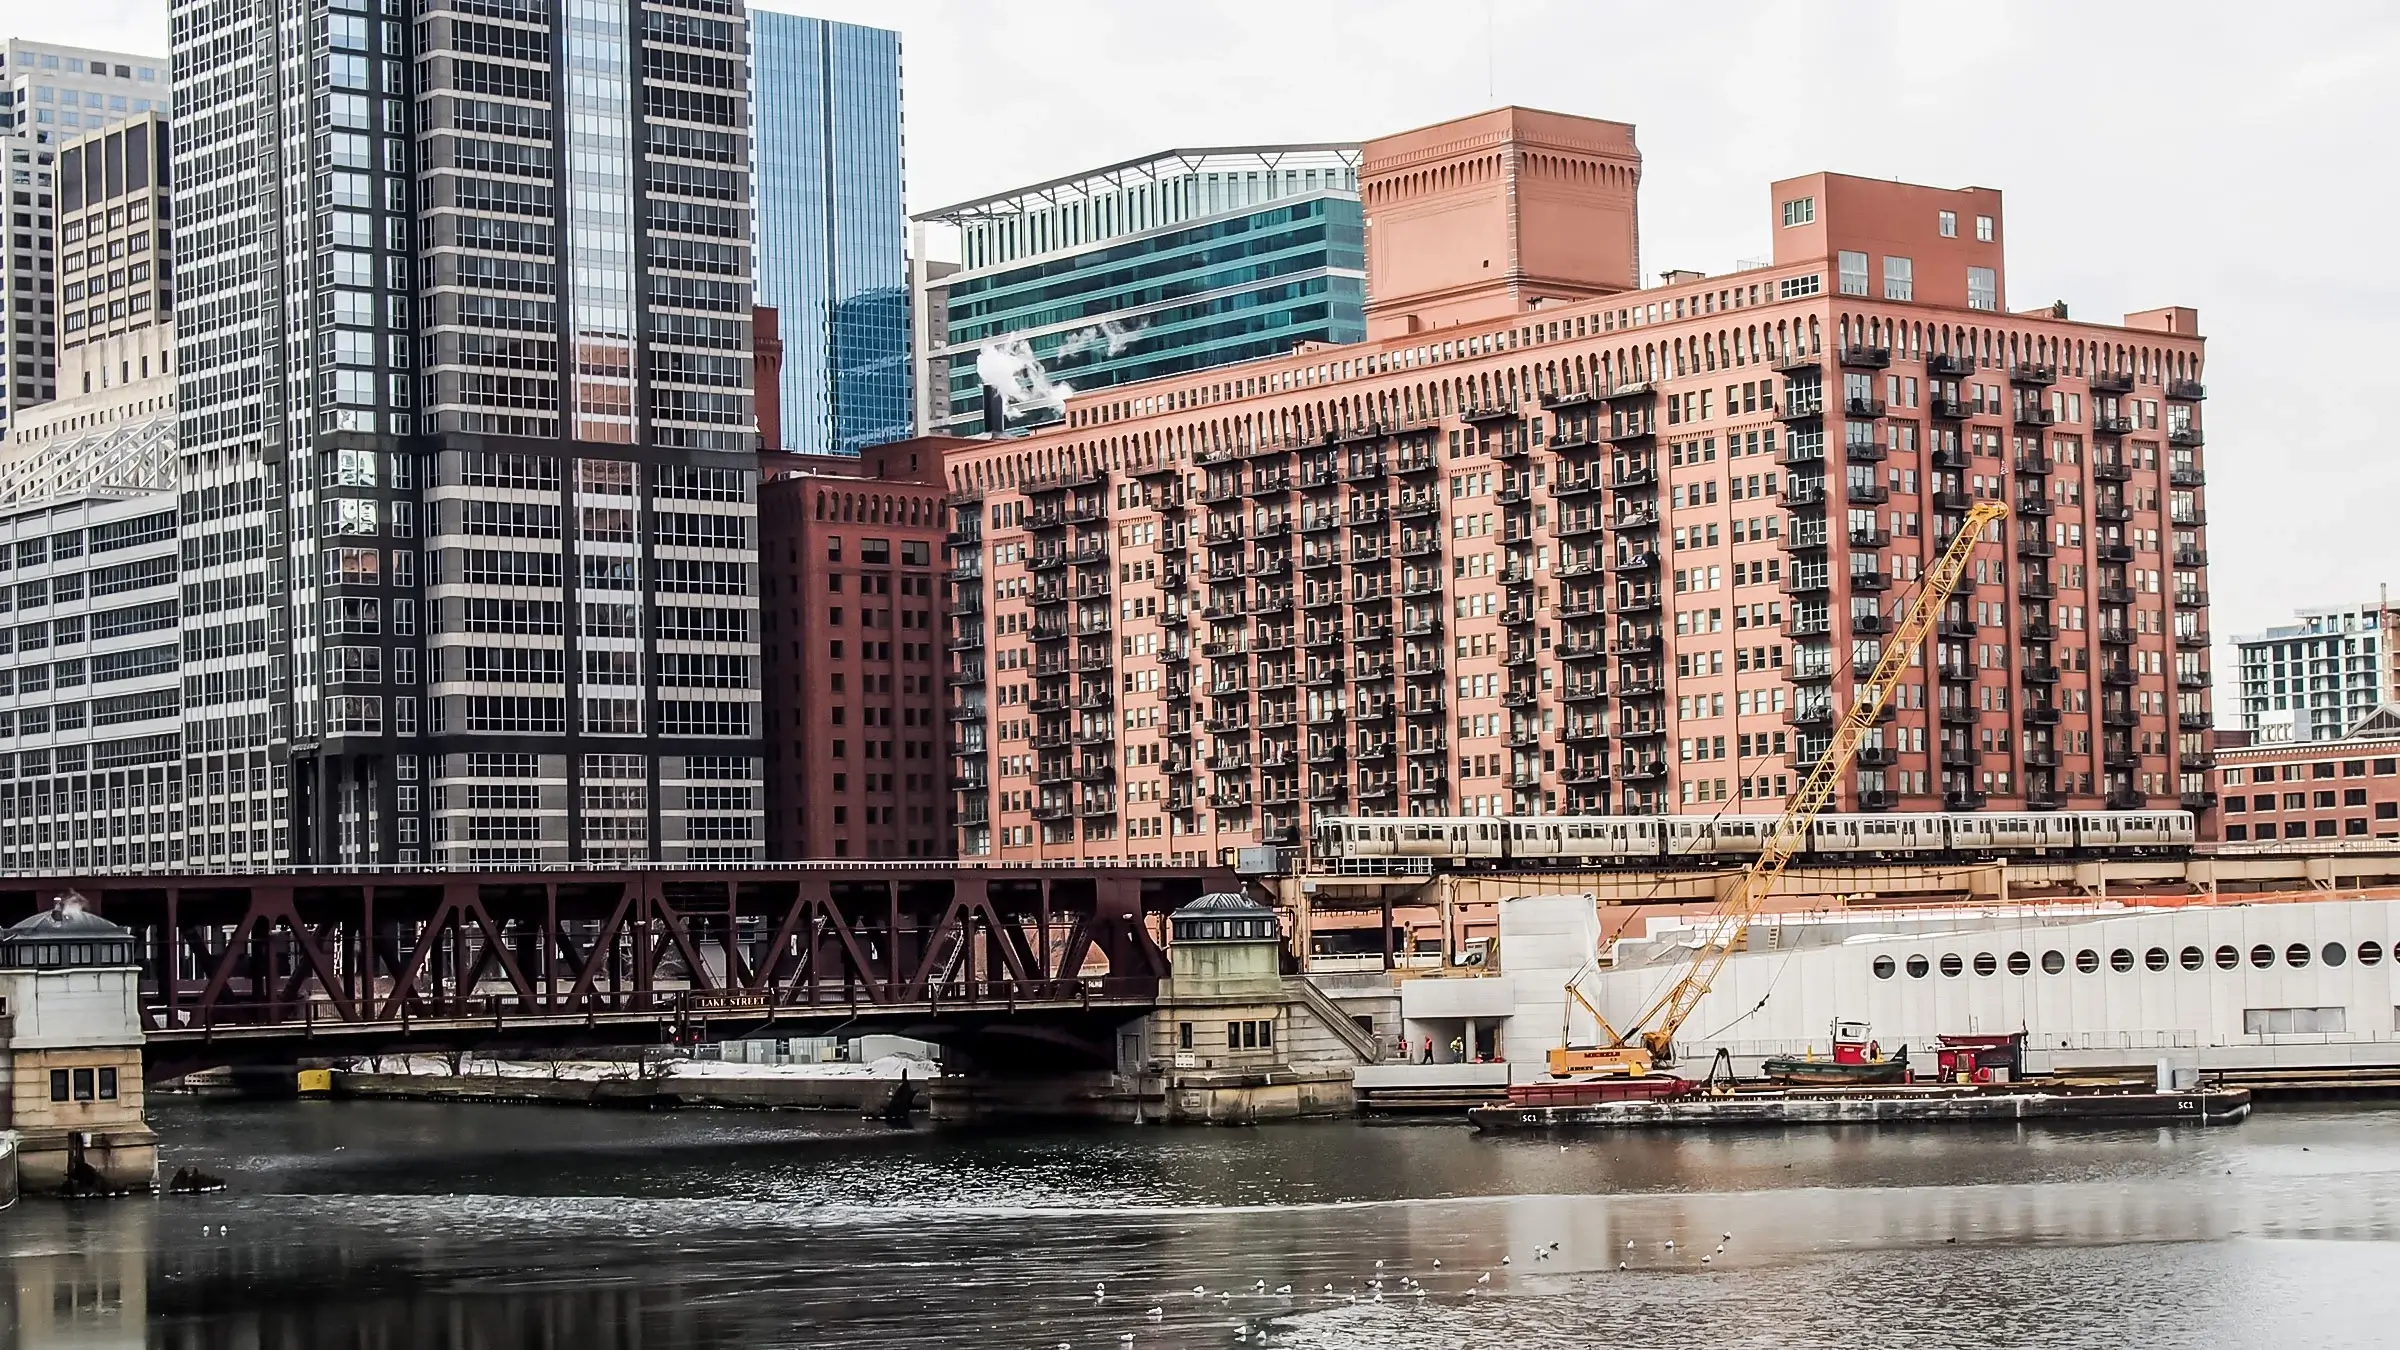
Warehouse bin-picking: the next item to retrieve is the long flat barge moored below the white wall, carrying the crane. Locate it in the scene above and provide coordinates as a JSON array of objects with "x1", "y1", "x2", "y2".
[{"x1": 1466, "y1": 1083, "x2": 2251, "y2": 1134}]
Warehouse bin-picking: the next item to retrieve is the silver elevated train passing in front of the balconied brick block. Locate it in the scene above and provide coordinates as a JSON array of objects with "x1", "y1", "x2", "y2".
[{"x1": 1313, "y1": 812, "x2": 2198, "y2": 870}]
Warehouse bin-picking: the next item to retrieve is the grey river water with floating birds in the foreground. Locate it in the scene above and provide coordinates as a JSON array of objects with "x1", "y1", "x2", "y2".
[{"x1": 0, "y1": 1100, "x2": 2400, "y2": 1350}]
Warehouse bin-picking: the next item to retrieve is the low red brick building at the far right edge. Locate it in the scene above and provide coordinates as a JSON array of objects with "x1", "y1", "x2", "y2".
[{"x1": 2218, "y1": 704, "x2": 2400, "y2": 843}]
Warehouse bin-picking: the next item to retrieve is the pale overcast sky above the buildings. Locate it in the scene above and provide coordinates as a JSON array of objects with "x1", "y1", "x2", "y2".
[{"x1": 46, "y1": 0, "x2": 2400, "y2": 672}]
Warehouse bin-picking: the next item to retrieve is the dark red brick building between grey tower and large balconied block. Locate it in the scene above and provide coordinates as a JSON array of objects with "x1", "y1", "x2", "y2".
[{"x1": 758, "y1": 437, "x2": 955, "y2": 860}]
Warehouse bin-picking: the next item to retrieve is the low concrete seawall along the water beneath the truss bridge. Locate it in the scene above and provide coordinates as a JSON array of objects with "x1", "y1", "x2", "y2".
[{"x1": 334, "y1": 1069, "x2": 902, "y2": 1110}]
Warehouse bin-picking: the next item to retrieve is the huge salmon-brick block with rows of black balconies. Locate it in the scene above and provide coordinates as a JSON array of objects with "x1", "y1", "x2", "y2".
[{"x1": 946, "y1": 108, "x2": 2213, "y2": 860}]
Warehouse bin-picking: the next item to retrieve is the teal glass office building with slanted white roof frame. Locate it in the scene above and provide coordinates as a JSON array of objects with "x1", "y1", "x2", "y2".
[{"x1": 919, "y1": 147, "x2": 1366, "y2": 435}]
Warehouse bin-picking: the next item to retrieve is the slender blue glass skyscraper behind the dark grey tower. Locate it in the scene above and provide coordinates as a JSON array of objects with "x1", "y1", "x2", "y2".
[{"x1": 751, "y1": 10, "x2": 914, "y2": 454}]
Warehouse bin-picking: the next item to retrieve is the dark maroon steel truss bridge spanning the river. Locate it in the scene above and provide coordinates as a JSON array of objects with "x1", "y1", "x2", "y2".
[{"x1": 0, "y1": 862, "x2": 1241, "y2": 1076}]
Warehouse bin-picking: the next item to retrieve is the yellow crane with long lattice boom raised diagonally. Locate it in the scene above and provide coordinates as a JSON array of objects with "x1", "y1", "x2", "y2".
[{"x1": 1550, "y1": 502, "x2": 2009, "y2": 1076}]
